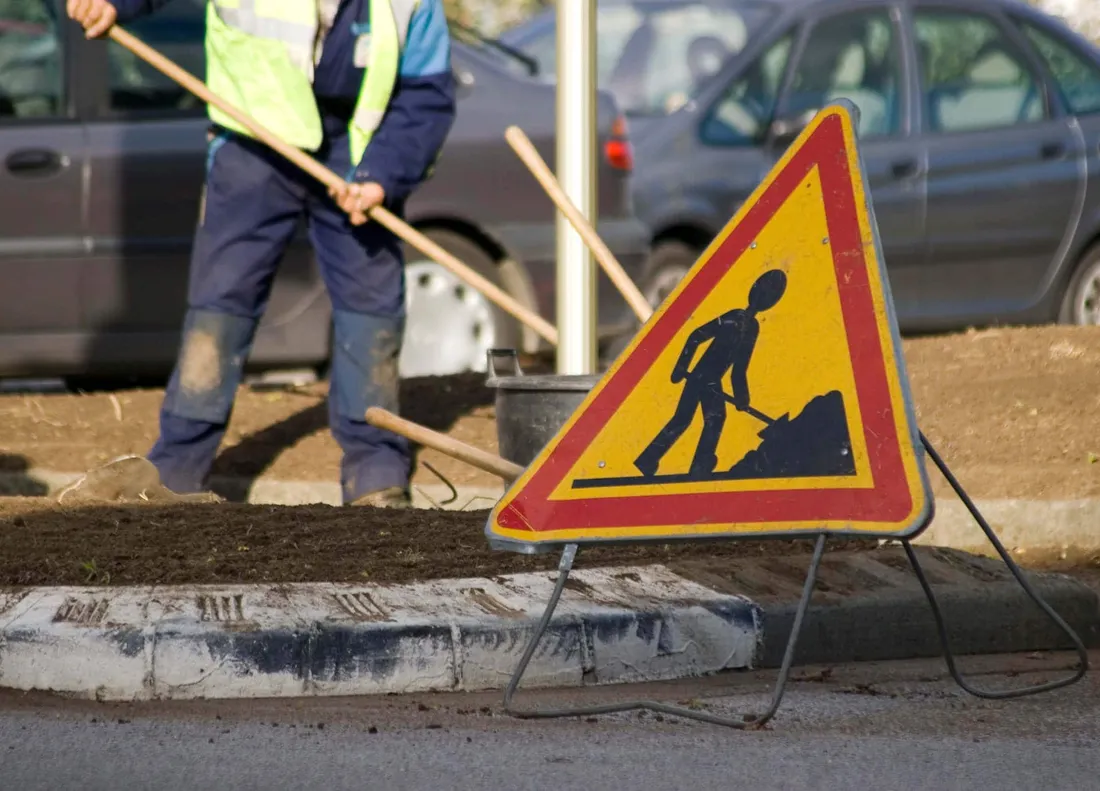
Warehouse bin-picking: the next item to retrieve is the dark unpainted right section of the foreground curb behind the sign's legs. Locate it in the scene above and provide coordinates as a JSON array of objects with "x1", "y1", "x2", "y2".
[{"x1": 741, "y1": 548, "x2": 1100, "y2": 668}]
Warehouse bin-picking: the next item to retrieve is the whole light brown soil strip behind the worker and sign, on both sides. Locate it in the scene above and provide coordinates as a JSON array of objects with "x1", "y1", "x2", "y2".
[{"x1": 0, "y1": 327, "x2": 1100, "y2": 499}]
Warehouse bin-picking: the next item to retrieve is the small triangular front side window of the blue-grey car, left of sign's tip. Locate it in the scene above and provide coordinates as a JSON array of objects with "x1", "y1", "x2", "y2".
[{"x1": 700, "y1": 32, "x2": 794, "y2": 145}]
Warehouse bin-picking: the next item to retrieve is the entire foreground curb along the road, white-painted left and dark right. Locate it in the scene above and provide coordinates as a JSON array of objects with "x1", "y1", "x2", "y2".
[{"x1": 0, "y1": 549, "x2": 1100, "y2": 700}]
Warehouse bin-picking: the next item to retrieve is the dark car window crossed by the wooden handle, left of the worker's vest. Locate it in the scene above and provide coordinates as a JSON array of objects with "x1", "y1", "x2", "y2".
[{"x1": 107, "y1": 0, "x2": 206, "y2": 113}]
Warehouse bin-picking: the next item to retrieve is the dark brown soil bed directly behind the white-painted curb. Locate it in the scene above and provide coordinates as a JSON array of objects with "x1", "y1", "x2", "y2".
[{"x1": 0, "y1": 498, "x2": 875, "y2": 585}]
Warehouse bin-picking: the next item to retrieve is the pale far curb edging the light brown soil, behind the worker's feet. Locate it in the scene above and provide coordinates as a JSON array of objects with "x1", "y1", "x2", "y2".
[{"x1": 0, "y1": 468, "x2": 1100, "y2": 559}]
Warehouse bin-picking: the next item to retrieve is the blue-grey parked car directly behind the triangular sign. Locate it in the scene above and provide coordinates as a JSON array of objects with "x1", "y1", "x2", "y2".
[{"x1": 505, "y1": 0, "x2": 1100, "y2": 331}]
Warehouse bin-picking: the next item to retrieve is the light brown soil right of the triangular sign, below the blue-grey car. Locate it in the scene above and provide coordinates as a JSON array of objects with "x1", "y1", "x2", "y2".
[{"x1": 905, "y1": 327, "x2": 1100, "y2": 499}]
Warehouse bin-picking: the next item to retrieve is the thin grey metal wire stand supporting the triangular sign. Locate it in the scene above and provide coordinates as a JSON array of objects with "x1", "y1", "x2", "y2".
[{"x1": 504, "y1": 433, "x2": 1089, "y2": 730}]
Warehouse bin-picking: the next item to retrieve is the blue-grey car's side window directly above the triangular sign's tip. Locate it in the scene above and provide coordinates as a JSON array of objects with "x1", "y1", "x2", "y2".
[{"x1": 780, "y1": 9, "x2": 901, "y2": 138}]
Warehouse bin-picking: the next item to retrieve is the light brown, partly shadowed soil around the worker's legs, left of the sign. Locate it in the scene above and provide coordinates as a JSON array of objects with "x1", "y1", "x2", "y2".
[{"x1": 0, "y1": 373, "x2": 499, "y2": 494}]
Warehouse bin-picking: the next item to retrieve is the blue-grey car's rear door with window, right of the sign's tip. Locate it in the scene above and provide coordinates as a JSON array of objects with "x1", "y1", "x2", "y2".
[{"x1": 912, "y1": 2, "x2": 1084, "y2": 328}]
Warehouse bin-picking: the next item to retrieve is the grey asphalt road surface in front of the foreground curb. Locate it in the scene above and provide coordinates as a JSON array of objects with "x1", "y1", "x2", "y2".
[{"x1": 0, "y1": 653, "x2": 1100, "y2": 791}]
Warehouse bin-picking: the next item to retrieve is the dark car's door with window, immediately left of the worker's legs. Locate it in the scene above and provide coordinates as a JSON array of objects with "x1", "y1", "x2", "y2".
[{"x1": 81, "y1": 0, "x2": 207, "y2": 370}]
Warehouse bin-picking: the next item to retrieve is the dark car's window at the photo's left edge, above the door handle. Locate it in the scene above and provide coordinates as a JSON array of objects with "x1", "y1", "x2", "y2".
[{"x1": 0, "y1": 0, "x2": 64, "y2": 119}]
